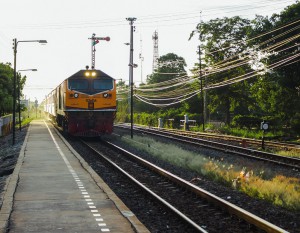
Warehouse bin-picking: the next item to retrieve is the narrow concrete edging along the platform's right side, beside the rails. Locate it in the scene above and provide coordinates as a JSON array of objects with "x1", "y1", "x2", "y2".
[{"x1": 54, "y1": 128, "x2": 150, "y2": 233}]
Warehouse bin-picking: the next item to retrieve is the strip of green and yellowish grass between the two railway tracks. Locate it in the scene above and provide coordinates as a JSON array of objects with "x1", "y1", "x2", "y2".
[{"x1": 112, "y1": 133, "x2": 300, "y2": 211}]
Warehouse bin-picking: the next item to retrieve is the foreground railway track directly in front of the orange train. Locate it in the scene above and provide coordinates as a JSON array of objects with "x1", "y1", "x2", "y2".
[{"x1": 82, "y1": 139, "x2": 286, "y2": 232}]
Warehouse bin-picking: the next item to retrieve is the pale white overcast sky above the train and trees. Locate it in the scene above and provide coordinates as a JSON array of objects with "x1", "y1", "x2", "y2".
[{"x1": 0, "y1": 0, "x2": 295, "y2": 103}]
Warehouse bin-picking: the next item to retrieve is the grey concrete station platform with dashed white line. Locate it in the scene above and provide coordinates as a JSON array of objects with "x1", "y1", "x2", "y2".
[{"x1": 0, "y1": 120, "x2": 149, "y2": 233}]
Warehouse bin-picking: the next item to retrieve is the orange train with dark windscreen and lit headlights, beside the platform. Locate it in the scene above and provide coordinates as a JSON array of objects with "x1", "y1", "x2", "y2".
[{"x1": 44, "y1": 69, "x2": 116, "y2": 137}]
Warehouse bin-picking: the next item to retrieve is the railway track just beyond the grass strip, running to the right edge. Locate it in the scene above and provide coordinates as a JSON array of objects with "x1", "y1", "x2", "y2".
[{"x1": 115, "y1": 125, "x2": 300, "y2": 171}]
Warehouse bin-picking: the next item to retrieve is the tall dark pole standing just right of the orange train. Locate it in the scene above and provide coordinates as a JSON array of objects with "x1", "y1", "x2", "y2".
[{"x1": 126, "y1": 17, "x2": 136, "y2": 138}]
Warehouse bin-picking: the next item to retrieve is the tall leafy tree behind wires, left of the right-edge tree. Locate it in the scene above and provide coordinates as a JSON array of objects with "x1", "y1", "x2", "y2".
[{"x1": 190, "y1": 16, "x2": 251, "y2": 124}]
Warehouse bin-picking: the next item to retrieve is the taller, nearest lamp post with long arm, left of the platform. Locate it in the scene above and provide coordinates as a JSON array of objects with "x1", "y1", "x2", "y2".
[{"x1": 12, "y1": 38, "x2": 47, "y2": 145}]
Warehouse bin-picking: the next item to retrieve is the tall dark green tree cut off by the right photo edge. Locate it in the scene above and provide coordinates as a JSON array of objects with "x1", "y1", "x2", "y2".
[{"x1": 251, "y1": 2, "x2": 300, "y2": 128}]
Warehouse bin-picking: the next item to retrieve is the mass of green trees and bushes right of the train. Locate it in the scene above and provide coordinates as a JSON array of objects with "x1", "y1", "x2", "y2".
[{"x1": 119, "y1": 2, "x2": 300, "y2": 137}]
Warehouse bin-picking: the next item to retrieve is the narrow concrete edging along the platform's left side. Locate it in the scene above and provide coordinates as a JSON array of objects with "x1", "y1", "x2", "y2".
[{"x1": 0, "y1": 125, "x2": 30, "y2": 233}]
